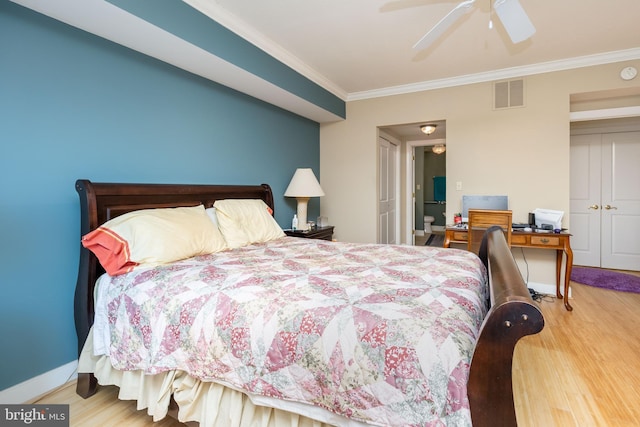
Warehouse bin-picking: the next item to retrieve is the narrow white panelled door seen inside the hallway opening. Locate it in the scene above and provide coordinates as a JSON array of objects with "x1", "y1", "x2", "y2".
[{"x1": 378, "y1": 137, "x2": 399, "y2": 244}]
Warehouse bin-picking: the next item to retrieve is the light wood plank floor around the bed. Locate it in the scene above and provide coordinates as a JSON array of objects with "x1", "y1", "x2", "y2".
[{"x1": 36, "y1": 272, "x2": 640, "y2": 427}]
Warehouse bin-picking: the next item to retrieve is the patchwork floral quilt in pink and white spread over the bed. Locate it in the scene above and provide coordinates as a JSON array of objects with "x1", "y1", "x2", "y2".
[{"x1": 94, "y1": 237, "x2": 487, "y2": 426}]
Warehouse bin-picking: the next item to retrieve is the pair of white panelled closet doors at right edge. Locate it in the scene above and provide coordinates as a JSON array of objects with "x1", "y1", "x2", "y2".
[{"x1": 570, "y1": 132, "x2": 640, "y2": 270}]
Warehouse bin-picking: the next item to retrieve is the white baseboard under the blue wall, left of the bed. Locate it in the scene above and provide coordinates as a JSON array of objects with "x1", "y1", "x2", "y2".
[{"x1": 0, "y1": 360, "x2": 78, "y2": 405}]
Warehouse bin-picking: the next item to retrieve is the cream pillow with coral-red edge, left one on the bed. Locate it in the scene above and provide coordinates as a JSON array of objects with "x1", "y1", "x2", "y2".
[{"x1": 82, "y1": 205, "x2": 227, "y2": 276}]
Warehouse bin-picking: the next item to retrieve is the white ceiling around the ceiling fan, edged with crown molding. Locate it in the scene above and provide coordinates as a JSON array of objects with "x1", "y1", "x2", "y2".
[{"x1": 190, "y1": 0, "x2": 640, "y2": 100}]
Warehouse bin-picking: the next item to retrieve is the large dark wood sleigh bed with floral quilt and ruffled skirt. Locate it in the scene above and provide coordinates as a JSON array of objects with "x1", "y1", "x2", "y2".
[{"x1": 74, "y1": 180, "x2": 544, "y2": 426}]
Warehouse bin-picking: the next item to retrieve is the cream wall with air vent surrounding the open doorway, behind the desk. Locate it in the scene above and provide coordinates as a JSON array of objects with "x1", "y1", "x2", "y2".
[{"x1": 320, "y1": 61, "x2": 640, "y2": 283}]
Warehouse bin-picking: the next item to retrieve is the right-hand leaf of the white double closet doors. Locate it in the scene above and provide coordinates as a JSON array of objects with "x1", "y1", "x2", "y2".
[{"x1": 600, "y1": 132, "x2": 640, "y2": 270}]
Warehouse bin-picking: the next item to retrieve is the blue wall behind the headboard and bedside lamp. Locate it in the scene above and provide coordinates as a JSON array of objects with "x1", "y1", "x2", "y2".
[{"x1": 0, "y1": 1, "x2": 319, "y2": 390}]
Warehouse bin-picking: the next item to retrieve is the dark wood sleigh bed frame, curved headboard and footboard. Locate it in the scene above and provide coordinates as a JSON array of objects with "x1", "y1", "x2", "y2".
[{"x1": 74, "y1": 180, "x2": 544, "y2": 427}]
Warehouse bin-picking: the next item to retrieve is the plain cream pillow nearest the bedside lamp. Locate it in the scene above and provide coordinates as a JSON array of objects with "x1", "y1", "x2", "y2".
[{"x1": 213, "y1": 199, "x2": 285, "y2": 248}]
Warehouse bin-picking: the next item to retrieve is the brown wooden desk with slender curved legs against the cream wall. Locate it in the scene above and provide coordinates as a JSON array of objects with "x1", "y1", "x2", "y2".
[{"x1": 443, "y1": 227, "x2": 573, "y2": 311}]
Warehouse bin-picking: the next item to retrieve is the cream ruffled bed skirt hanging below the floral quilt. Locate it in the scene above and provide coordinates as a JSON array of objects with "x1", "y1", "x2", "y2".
[{"x1": 78, "y1": 331, "x2": 364, "y2": 427}]
